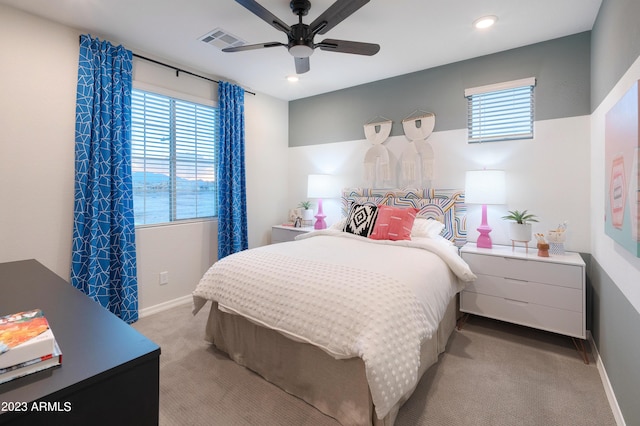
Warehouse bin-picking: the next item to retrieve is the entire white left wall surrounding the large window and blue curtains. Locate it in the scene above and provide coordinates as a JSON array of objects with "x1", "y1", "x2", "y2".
[{"x1": 0, "y1": 5, "x2": 288, "y2": 313}]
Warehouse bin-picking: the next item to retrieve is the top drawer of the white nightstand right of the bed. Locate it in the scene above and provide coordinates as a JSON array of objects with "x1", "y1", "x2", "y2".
[{"x1": 463, "y1": 253, "x2": 582, "y2": 290}]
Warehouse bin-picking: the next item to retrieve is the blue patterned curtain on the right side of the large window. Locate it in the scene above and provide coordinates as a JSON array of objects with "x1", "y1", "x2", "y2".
[{"x1": 217, "y1": 81, "x2": 249, "y2": 259}]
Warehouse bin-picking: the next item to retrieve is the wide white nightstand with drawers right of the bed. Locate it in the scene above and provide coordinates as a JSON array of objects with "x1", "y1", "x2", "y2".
[{"x1": 460, "y1": 243, "x2": 589, "y2": 363}]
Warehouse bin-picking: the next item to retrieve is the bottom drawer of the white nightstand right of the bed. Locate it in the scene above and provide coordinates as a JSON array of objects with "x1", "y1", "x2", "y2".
[{"x1": 460, "y1": 291, "x2": 586, "y2": 339}]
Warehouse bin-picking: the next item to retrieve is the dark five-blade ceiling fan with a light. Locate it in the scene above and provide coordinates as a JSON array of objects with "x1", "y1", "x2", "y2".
[{"x1": 222, "y1": 0, "x2": 380, "y2": 74}]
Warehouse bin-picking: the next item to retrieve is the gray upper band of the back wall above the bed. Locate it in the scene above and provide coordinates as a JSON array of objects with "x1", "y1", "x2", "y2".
[{"x1": 289, "y1": 32, "x2": 591, "y2": 147}]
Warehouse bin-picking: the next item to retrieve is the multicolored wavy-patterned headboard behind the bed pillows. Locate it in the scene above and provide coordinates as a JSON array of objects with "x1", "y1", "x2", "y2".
[{"x1": 342, "y1": 188, "x2": 467, "y2": 247}]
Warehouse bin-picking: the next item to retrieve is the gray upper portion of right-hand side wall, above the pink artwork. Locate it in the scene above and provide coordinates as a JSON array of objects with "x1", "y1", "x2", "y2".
[{"x1": 591, "y1": 0, "x2": 640, "y2": 112}]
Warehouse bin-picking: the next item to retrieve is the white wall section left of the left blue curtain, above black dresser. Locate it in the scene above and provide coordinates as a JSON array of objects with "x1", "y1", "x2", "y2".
[{"x1": 0, "y1": 5, "x2": 79, "y2": 279}]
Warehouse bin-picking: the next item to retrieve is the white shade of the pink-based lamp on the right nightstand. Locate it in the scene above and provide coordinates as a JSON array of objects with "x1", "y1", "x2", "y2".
[{"x1": 464, "y1": 170, "x2": 506, "y2": 204}]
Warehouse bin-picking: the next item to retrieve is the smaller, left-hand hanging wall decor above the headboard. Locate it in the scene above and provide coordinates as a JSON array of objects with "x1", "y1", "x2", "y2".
[{"x1": 364, "y1": 120, "x2": 393, "y2": 188}]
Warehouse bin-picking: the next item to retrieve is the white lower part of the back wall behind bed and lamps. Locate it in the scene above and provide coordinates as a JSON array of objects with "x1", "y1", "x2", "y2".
[{"x1": 282, "y1": 115, "x2": 591, "y2": 252}]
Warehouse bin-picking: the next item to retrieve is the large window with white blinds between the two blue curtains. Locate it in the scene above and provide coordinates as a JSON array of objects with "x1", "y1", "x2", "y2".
[{"x1": 131, "y1": 89, "x2": 218, "y2": 225}]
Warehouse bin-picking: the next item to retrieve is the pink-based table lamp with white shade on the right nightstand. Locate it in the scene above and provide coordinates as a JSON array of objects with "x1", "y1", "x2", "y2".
[{"x1": 464, "y1": 170, "x2": 506, "y2": 248}]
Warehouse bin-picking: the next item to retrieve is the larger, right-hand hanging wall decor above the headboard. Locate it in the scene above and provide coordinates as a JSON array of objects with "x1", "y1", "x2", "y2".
[{"x1": 400, "y1": 111, "x2": 436, "y2": 188}]
